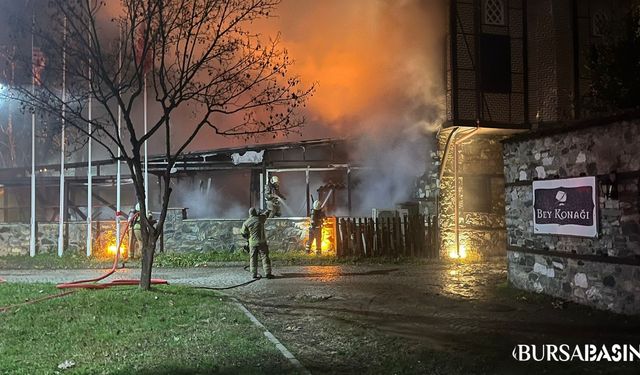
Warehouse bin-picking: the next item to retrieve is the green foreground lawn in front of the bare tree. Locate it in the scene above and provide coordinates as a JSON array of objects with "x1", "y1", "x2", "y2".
[{"x1": 0, "y1": 283, "x2": 295, "y2": 374}]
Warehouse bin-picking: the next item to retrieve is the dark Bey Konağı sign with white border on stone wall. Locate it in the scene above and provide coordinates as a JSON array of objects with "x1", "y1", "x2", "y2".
[{"x1": 533, "y1": 176, "x2": 598, "y2": 237}]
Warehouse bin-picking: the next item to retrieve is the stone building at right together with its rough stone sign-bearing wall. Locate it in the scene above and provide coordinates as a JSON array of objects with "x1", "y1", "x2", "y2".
[{"x1": 437, "y1": 0, "x2": 640, "y2": 313}]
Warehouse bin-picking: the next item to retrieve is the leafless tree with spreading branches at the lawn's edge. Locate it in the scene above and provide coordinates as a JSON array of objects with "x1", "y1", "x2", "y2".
[{"x1": 7, "y1": 0, "x2": 313, "y2": 290}]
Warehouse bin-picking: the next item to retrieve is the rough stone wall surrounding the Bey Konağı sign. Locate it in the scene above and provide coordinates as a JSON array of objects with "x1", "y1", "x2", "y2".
[{"x1": 504, "y1": 121, "x2": 640, "y2": 313}]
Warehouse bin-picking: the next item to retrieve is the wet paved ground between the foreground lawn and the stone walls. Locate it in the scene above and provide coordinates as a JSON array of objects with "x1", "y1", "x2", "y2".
[{"x1": 5, "y1": 259, "x2": 640, "y2": 374}]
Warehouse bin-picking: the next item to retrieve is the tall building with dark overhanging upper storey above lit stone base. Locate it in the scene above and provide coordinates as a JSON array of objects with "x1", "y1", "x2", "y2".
[{"x1": 437, "y1": 0, "x2": 635, "y2": 258}]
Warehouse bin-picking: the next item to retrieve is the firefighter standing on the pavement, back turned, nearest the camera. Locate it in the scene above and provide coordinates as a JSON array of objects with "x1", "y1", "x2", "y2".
[{"x1": 240, "y1": 207, "x2": 273, "y2": 279}]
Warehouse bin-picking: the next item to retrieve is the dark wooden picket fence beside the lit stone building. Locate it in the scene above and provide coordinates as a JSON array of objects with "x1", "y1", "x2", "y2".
[{"x1": 336, "y1": 215, "x2": 438, "y2": 258}]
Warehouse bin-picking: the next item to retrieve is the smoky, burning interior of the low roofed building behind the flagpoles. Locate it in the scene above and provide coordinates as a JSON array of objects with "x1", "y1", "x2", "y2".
[{"x1": 0, "y1": 139, "x2": 436, "y2": 256}]
